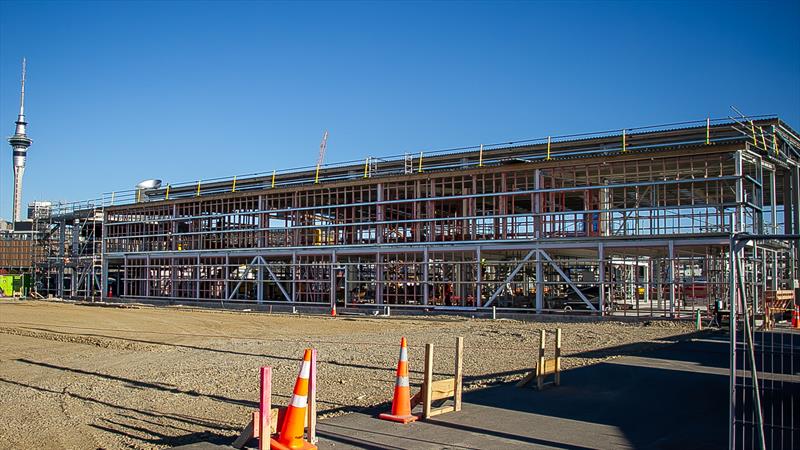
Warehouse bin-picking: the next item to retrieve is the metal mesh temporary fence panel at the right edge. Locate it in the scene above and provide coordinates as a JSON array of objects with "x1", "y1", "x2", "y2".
[{"x1": 728, "y1": 234, "x2": 800, "y2": 450}]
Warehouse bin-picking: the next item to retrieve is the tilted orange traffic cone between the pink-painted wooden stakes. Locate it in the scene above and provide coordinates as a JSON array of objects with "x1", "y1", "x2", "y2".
[{"x1": 269, "y1": 349, "x2": 317, "y2": 450}]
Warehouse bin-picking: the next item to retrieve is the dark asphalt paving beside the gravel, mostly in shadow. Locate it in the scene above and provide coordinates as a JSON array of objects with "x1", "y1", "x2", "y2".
[{"x1": 319, "y1": 335, "x2": 728, "y2": 449}]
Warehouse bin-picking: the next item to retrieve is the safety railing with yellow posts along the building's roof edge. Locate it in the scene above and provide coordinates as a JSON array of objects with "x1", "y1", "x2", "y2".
[{"x1": 40, "y1": 115, "x2": 776, "y2": 216}]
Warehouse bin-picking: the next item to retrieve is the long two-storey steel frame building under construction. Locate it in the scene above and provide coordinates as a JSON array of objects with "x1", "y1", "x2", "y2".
[{"x1": 25, "y1": 117, "x2": 800, "y2": 317}]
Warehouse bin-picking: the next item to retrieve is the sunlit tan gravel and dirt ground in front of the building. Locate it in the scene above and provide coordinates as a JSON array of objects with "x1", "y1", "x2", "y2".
[{"x1": 0, "y1": 300, "x2": 691, "y2": 449}]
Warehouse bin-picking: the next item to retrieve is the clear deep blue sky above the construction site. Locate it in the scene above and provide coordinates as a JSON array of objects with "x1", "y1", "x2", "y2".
[{"x1": 0, "y1": 1, "x2": 800, "y2": 218}]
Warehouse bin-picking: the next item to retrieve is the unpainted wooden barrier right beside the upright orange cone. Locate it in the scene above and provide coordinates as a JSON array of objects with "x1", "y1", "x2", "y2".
[{"x1": 411, "y1": 337, "x2": 464, "y2": 419}]
